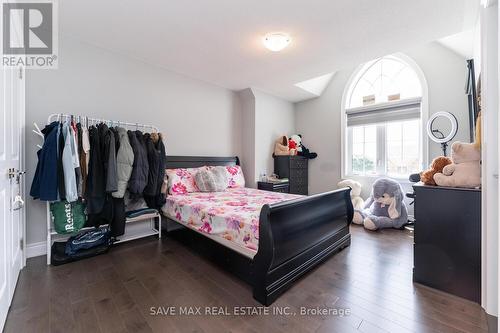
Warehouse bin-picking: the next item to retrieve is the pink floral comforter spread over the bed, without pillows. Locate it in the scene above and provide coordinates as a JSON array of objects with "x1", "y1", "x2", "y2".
[{"x1": 162, "y1": 187, "x2": 301, "y2": 251}]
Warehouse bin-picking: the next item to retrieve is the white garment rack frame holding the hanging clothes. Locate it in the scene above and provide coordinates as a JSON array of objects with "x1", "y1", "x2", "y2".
[{"x1": 47, "y1": 113, "x2": 161, "y2": 265}]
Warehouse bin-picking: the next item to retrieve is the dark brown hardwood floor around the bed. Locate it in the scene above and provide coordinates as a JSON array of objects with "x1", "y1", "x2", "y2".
[{"x1": 5, "y1": 226, "x2": 487, "y2": 333}]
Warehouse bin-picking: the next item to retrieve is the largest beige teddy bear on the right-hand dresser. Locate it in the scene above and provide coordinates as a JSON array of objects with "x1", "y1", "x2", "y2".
[{"x1": 434, "y1": 141, "x2": 481, "y2": 188}]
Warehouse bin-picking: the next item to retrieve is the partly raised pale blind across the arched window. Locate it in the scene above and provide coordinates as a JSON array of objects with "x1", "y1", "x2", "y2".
[{"x1": 346, "y1": 97, "x2": 421, "y2": 127}]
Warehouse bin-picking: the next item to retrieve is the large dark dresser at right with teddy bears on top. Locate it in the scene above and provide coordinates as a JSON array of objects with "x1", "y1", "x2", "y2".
[{"x1": 413, "y1": 183, "x2": 481, "y2": 303}]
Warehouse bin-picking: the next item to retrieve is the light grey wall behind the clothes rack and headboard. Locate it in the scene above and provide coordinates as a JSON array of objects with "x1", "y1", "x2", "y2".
[{"x1": 26, "y1": 38, "x2": 241, "y2": 245}]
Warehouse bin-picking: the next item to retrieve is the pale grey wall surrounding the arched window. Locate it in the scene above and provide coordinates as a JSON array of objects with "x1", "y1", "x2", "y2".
[{"x1": 295, "y1": 43, "x2": 469, "y2": 198}]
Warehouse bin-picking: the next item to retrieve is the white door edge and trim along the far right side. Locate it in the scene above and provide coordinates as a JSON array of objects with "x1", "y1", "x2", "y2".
[{"x1": 480, "y1": 1, "x2": 500, "y2": 316}]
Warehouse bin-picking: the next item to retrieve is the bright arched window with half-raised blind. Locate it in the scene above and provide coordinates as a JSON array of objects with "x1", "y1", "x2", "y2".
[{"x1": 343, "y1": 55, "x2": 425, "y2": 178}]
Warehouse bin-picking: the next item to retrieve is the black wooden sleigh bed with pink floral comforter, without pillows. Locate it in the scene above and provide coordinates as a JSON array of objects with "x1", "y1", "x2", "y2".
[{"x1": 162, "y1": 156, "x2": 354, "y2": 306}]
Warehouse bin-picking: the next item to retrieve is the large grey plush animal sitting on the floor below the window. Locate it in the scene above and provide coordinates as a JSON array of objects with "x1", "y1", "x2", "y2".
[{"x1": 352, "y1": 178, "x2": 408, "y2": 230}]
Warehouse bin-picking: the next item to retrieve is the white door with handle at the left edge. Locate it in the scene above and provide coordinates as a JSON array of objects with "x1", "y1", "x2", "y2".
[{"x1": 0, "y1": 63, "x2": 25, "y2": 329}]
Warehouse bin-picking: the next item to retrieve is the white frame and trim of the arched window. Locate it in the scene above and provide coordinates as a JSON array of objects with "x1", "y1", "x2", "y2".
[{"x1": 340, "y1": 53, "x2": 429, "y2": 183}]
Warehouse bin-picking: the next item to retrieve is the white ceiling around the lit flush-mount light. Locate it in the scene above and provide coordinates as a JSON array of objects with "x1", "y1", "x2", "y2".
[{"x1": 59, "y1": 0, "x2": 479, "y2": 101}]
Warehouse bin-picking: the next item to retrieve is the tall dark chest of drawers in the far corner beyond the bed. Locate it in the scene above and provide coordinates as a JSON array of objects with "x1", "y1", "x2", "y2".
[{"x1": 274, "y1": 156, "x2": 309, "y2": 195}]
